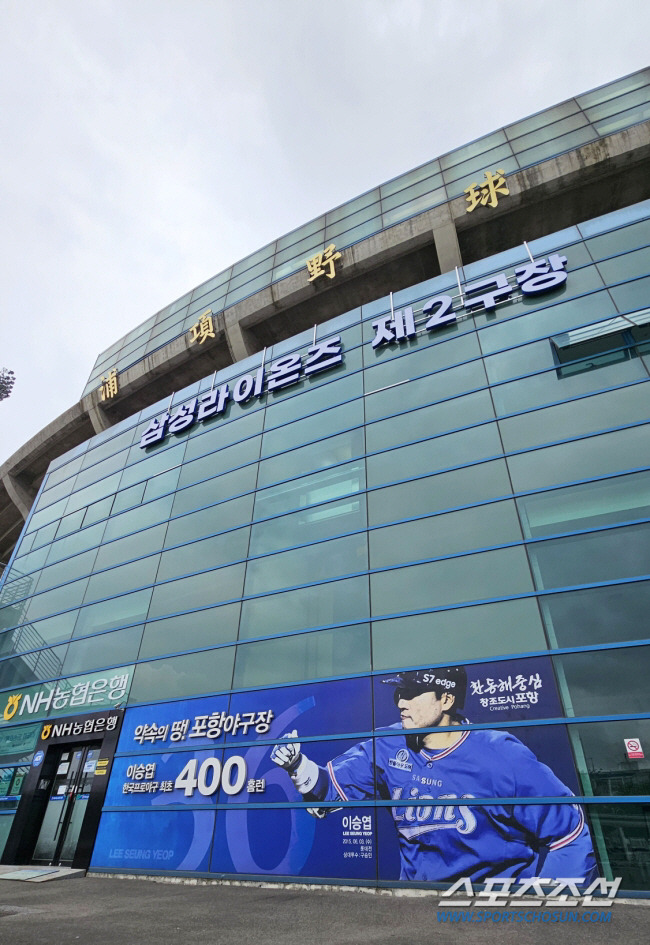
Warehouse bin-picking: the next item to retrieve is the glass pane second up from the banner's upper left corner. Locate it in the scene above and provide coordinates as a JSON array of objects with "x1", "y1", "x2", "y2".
[{"x1": 140, "y1": 603, "x2": 240, "y2": 659}]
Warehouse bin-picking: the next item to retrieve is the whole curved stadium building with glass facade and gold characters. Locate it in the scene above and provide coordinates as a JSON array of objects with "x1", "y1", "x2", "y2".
[{"x1": 0, "y1": 70, "x2": 650, "y2": 893}]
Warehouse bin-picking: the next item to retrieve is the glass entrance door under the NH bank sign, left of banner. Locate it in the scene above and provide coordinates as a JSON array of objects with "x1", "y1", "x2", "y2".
[{"x1": 33, "y1": 745, "x2": 100, "y2": 866}]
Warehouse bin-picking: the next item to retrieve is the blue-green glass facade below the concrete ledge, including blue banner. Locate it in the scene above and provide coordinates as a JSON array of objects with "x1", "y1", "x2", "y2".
[{"x1": 0, "y1": 142, "x2": 650, "y2": 891}]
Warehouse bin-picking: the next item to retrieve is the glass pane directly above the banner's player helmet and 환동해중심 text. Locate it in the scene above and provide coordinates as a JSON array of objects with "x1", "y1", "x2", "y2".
[{"x1": 372, "y1": 599, "x2": 546, "y2": 670}]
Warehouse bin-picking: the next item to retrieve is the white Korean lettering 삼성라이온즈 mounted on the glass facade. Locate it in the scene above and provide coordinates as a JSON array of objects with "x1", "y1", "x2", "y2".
[{"x1": 140, "y1": 336, "x2": 343, "y2": 449}]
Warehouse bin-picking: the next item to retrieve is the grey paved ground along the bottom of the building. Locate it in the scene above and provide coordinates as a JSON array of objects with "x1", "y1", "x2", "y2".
[{"x1": 0, "y1": 877, "x2": 650, "y2": 945}]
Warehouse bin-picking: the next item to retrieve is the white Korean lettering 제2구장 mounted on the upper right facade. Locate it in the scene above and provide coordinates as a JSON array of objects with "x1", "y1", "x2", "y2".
[{"x1": 372, "y1": 253, "x2": 567, "y2": 348}]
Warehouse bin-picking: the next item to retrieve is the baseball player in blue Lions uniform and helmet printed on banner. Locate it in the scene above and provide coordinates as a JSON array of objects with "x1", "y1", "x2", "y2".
[{"x1": 271, "y1": 666, "x2": 596, "y2": 882}]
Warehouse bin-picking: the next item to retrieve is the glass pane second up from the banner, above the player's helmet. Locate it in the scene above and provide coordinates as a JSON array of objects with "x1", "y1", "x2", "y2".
[{"x1": 370, "y1": 548, "x2": 533, "y2": 616}]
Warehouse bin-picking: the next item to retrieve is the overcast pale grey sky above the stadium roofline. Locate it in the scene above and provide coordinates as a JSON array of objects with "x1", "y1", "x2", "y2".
[{"x1": 0, "y1": 0, "x2": 650, "y2": 463}]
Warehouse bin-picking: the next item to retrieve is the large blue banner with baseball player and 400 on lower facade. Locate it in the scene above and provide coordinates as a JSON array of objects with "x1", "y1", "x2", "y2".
[{"x1": 93, "y1": 657, "x2": 595, "y2": 882}]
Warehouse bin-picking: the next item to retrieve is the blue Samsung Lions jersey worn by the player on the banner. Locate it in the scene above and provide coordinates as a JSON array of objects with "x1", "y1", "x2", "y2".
[{"x1": 306, "y1": 724, "x2": 596, "y2": 882}]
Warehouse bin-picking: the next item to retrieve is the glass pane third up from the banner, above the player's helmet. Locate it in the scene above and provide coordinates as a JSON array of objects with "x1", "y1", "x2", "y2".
[{"x1": 369, "y1": 502, "x2": 521, "y2": 568}]
